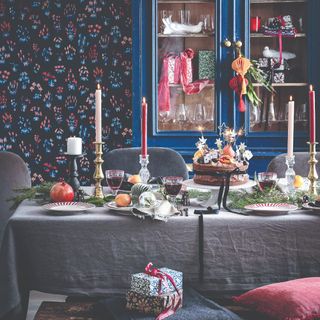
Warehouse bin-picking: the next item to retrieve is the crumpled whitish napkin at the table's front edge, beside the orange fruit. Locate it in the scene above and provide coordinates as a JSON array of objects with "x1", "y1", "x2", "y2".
[{"x1": 132, "y1": 200, "x2": 180, "y2": 221}]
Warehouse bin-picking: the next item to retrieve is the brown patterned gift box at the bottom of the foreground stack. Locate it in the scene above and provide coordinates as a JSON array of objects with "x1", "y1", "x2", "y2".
[{"x1": 126, "y1": 290, "x2": 183, "y2": 316}]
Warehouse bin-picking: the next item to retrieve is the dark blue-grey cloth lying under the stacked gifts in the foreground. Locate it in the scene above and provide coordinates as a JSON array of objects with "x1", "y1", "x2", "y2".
[{"x1": 97, "y1": 289, "x2": 242, "y2": 320}]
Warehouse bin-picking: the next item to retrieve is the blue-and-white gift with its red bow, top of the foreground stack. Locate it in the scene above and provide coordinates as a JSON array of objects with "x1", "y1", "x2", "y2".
[{"x1": 131, "y1": 263, "x2": 183, "y2": 296}]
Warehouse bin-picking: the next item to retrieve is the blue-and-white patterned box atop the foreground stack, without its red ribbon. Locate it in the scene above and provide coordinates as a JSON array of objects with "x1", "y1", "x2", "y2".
[{"x1": 131, "y1": 268, "x2": 183, "y2": 296}]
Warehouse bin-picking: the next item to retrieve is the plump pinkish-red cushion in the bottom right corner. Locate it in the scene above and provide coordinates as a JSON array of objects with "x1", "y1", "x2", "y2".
[{"x1": 234, "y1": 277, "x2": 320, "y2": 320}]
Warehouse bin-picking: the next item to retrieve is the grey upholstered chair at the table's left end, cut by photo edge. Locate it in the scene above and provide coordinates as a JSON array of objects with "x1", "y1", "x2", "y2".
[{"x1": 0, "y1": 151, "x2": 31, "y2": 246}]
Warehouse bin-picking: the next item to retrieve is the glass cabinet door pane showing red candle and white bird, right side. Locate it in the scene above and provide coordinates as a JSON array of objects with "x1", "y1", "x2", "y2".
[{"x1": 250, "y1": 0, "x2": 308, "y2": 132}]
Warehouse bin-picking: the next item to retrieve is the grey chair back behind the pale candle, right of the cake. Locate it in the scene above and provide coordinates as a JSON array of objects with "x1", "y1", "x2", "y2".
[{"x1": 267, "y1": 152, "x2": 320, "y2": 178}]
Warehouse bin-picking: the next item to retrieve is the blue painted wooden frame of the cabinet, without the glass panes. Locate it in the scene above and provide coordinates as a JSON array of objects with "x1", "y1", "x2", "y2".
[{"x1": 132, "y1": 0, "x2": 320, "y2": 174}]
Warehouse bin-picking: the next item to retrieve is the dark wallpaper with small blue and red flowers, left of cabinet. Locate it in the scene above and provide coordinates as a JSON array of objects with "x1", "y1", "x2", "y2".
[{"x1": 0, "y1": 0, "x2": 132, "y2": 185}]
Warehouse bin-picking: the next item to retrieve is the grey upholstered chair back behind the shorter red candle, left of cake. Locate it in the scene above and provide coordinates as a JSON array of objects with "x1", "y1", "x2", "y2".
[{"x1": 104, "y1": 147, "x2": 189, "y2": 180}]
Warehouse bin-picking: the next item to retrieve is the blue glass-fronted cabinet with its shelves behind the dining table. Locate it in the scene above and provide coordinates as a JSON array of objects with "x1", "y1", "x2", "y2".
[{"x1": 132, "y1": 0, "x2": 320, "y2": 174}]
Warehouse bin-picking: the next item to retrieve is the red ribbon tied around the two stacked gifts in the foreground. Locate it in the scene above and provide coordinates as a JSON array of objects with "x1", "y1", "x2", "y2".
[{"x1": 144, "y1": 262, "x2": 181, "y2": 320}]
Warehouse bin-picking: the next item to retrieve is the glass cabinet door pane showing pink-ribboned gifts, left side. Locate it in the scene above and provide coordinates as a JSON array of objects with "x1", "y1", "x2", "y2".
[{"x1": 155, "y1": 0, "x2": 216, "y2": 132}]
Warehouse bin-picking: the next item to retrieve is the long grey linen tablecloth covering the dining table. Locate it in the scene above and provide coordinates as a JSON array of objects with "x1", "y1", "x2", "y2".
[{"x1": 0, "y1": 202, "x2": 320, "y2": 317}]
